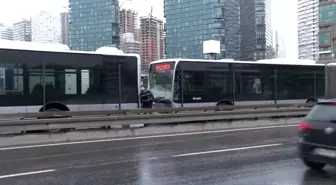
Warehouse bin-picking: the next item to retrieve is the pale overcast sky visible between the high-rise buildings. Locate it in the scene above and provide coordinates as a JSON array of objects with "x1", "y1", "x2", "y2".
[{"x1": 0, "y1": 0, "x2": 297, "y2": 58}]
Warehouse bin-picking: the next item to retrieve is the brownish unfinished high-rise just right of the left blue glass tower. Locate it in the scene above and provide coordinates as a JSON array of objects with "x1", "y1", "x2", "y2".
[{"x1": 119, "y1": 9, "x2": 140, "y2": 40}]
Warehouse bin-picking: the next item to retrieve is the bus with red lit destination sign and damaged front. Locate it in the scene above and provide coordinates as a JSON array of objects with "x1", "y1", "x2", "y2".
[{"x1": 148, "y1": 59, "x2": 325, "y2": 107}]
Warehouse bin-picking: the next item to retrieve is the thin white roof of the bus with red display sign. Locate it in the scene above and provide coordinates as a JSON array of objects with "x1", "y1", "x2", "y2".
[{"x1": 151, "y1": 59, "x2": 325, "y2": 66}]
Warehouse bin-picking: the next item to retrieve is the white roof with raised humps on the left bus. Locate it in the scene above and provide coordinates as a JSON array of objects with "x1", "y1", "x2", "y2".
[{"x1": 0, "y1": 39, "x2": 140, "y2": 59}]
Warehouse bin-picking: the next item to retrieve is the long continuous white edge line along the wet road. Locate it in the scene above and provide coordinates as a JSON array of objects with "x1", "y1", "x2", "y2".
[{"x1": 0, "y1": 124, "x2": 297, "y2": 151}]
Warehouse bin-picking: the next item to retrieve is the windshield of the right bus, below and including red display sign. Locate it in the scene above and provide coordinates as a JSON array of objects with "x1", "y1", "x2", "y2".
[{"x1": 149, "y1": 63, "x2": 174, "y2": 99}]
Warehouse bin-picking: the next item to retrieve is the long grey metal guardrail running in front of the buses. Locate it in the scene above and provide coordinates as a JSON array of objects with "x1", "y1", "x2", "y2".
[{"x1": 0, "y1": 105, "x2": 309, "y2": 133}]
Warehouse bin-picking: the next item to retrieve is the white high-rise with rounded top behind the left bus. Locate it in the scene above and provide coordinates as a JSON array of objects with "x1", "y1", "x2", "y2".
[{"x1": 31, "y1": 11, "x2": 61, "y2": 43}]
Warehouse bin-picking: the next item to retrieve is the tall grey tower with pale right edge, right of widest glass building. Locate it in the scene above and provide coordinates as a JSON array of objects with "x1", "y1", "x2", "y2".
[{"x1": 239, "y1": 0, "x2": 274, "y2": 60}]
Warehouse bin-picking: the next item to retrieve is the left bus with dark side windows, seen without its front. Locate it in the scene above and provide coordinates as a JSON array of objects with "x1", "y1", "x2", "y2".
[{"x1": 0, "y1": 40, "x2": 141, "y2": 113}]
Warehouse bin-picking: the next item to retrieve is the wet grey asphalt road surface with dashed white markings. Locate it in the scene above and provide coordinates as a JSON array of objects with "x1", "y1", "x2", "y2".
[{"x1": 0, "y1": 127, "x2": 336, "y2": 185}]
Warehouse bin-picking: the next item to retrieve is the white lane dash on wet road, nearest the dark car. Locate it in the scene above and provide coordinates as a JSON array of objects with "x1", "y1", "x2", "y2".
[{"x1": 172, "y1": 143, "x2": 283, "y2": 157}]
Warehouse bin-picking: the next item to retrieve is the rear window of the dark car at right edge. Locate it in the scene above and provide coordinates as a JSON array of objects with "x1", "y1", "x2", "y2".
[{"x1": 306, "y1": 104, "x2": 336, "y2": 121}]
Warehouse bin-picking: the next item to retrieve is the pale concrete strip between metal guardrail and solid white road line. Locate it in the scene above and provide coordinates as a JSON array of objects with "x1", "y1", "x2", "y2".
[{"x1": 0, "y1": 118, "x2": 302, "y2": 150}]
